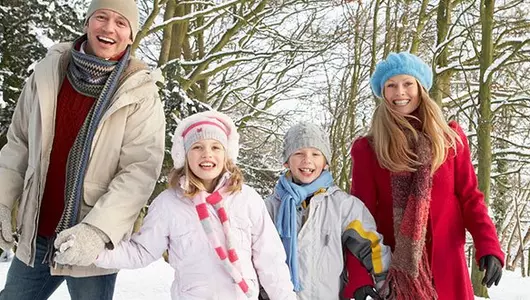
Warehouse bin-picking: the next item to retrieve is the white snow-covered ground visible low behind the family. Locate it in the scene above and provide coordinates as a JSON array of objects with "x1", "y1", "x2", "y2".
[{"x1": 0, "y1": 260, "x2": 530, "y2": 300}]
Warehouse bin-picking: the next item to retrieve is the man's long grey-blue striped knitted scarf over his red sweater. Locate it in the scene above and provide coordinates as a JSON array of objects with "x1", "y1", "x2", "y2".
[{"x1": 55, "y1": 36, "x2": 130, "y2": 233}]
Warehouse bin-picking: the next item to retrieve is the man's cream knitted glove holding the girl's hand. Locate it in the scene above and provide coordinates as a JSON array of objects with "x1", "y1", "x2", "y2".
[{"x1": 54, "y1": 223, "x2": 110, "y2": 266}]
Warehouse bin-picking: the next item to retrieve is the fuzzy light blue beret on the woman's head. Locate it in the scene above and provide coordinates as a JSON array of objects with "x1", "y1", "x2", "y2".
[{"x1": 370, "y1": 52, "x2": 432, "y2": 98}]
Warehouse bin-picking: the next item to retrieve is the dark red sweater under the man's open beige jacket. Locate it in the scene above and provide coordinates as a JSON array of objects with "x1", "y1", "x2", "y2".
[{"x1": 38, "y1": 76, "x2": 95, "y2": 237}]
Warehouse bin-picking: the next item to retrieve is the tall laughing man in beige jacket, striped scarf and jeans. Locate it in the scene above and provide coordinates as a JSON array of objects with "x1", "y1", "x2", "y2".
[{"x1": 0, "y1": 0, "x2": 165, "y2": 300}]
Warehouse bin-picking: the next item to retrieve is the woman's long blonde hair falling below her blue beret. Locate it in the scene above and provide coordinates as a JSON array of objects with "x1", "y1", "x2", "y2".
[{"x1": 368, "y1": 80, "x2": 462, "y2": 174}]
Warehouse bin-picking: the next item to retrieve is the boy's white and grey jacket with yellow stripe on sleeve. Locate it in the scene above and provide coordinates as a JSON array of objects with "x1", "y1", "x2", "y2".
[{"x1": 265, "y1": 186, "x2": 391, "y2": 300}]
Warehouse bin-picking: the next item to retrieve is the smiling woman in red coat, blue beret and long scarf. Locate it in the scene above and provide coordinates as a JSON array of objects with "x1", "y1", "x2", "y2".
[{"x1": 347, "y1": 52, "x2": 504, "y2": 300}]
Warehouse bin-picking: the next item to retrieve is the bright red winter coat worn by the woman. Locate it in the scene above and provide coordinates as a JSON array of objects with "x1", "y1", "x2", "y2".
[{"x1": 344, "y1": 122, "x2": 504, "y2": 300}]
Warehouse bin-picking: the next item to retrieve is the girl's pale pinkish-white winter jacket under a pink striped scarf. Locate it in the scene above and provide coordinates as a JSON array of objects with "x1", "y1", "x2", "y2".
[{"x1": 96, "y1": 185, "x2": 296, "y2": 300}]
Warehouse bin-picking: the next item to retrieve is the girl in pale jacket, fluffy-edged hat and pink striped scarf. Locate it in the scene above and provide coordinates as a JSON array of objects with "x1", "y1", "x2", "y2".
[{"x1": 59, "y1": 111, "x2": 296, "y2": 300}]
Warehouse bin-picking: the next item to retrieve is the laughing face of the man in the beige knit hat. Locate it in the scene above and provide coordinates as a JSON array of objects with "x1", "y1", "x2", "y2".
[{"x1": 85, "y1": 9, "x2": 132, "y2": 59}]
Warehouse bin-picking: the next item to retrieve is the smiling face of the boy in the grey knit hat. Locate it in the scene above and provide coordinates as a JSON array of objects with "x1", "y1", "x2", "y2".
[{"x1": 284, "y1": 148, "x2": 327, "y2": 184}]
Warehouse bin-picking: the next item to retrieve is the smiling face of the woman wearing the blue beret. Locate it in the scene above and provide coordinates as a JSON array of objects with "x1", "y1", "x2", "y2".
[{"x1": 383, "y1": 75, "x2": 420, "y2": 115}]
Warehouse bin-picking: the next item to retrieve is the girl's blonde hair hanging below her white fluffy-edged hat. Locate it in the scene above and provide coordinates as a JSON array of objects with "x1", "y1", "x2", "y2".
[{"x1": 168, "y1": 159, "x2": 243, "y2": 198}]
